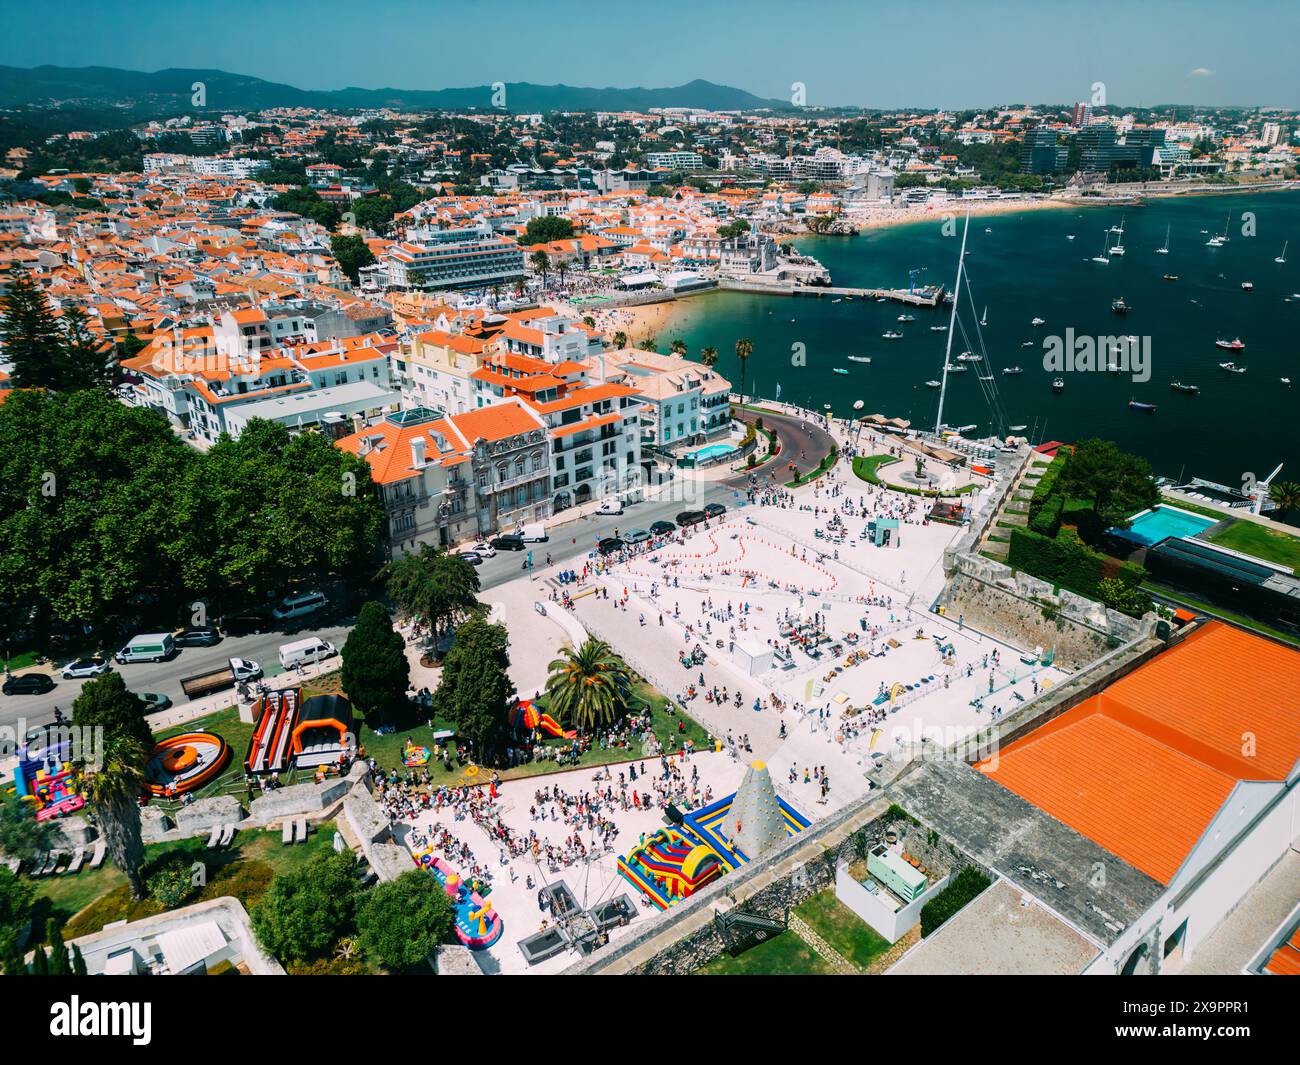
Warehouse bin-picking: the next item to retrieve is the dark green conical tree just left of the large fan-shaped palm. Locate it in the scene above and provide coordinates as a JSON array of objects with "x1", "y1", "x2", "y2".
[{"x1": 433, "y1": 618, "x2": 515, "y2": 762}]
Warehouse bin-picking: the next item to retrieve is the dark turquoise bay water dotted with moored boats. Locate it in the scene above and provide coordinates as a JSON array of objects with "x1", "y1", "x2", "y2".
[{"x1": 658, "y1": 191, "x2": 1300, "y2": 485}]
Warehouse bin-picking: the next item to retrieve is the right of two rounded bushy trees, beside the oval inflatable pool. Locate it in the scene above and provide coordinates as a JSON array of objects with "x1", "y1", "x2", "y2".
[{"x1": 356, "y1": 869, "x2": 452, "y2": 971}]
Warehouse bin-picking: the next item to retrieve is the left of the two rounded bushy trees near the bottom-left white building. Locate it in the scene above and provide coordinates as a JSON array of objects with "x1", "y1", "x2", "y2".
[{"x1": 250, "y1": 850, "x2": 361, "y2": 961}]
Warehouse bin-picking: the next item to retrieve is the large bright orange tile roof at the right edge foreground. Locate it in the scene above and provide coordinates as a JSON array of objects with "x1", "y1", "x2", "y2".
[{"x1": 978, "y1": 622, "x2": 1300, "y2": 884}]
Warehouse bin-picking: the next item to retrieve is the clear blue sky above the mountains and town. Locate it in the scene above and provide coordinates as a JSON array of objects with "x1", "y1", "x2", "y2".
[{"x1": 0, "y1": 0, "x2": 1300, "y2": 108}]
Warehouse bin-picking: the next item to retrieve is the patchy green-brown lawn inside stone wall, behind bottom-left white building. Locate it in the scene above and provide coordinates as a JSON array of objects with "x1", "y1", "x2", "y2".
[{"x1": 33, "y1": 822, "x2": 334, "y2": 939}]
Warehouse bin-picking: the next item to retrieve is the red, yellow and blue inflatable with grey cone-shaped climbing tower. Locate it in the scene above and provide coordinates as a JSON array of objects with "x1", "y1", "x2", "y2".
[{"x1": 619, "y1": 762, "x2": 810, "y2": 909}]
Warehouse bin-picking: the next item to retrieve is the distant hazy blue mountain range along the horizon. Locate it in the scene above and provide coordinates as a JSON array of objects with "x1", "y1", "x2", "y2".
[{"x1": 0, "y1": 66, "x2": 790, "y2": 114}]
